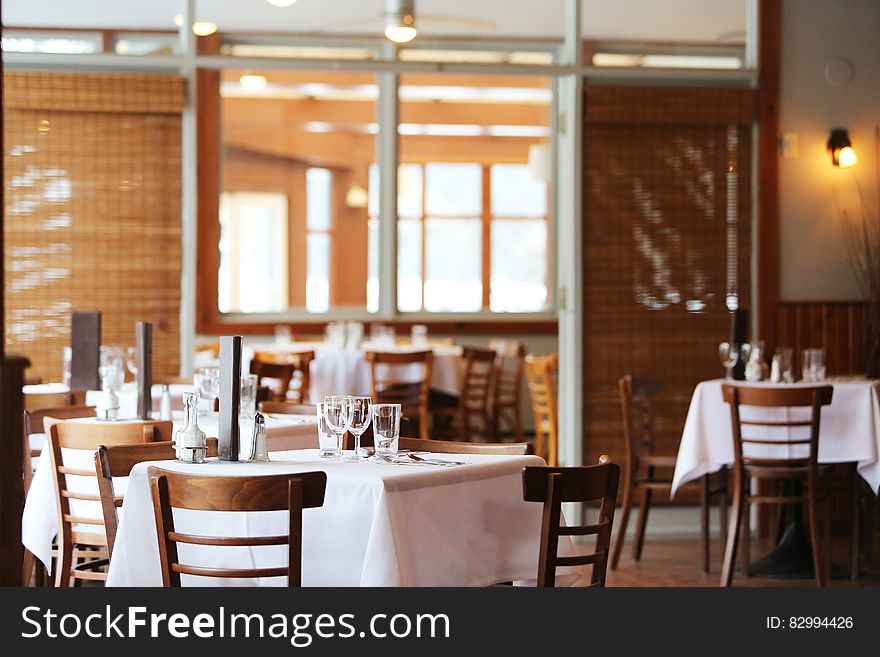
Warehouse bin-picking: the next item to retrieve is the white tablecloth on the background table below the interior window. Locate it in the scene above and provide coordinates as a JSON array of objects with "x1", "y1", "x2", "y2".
[{"x1": 241, "y1": 342, "x2": 463, "y2": 401}]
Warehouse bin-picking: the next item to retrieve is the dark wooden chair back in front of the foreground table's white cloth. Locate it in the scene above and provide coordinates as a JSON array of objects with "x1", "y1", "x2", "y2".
[{"x1": 147, "y1": 466, "x2": 327, "y2": 587}]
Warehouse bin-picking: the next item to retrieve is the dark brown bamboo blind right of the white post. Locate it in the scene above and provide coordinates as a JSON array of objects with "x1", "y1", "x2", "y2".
[{"x1": 583, "y1": 86, "x2": 754, "y2": 476}]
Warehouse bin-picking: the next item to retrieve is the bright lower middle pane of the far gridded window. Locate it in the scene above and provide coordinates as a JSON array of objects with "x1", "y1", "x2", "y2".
[{"x1": 425, "y1": 219, "x2": 483, "y2": 312}]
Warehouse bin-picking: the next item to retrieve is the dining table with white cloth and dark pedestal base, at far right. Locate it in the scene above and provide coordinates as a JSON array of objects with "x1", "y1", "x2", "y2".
[{"x1": 671, "y1": 377, "x2": 880, "y2": 577}]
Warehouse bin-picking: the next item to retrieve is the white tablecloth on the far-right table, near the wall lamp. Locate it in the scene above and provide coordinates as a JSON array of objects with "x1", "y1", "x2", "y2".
[{"x1": 672, "y1": 379, "x2": 880, "y2": 495}]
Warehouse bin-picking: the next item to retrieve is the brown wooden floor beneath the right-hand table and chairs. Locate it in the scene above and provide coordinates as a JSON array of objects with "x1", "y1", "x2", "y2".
[{"x1": 606, "y1": 539, "x2": 880, "y2": 586}]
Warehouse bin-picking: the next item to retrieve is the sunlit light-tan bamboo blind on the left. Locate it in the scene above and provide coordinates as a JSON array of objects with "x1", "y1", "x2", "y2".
[{"x1": 4, "y1": 72, "x2": 185, "y2": 381}]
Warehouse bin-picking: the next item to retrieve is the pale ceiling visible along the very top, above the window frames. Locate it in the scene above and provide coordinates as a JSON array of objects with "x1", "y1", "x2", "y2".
[{"x1": 2, "y1": 0, "x2": 746, "y2": 43}]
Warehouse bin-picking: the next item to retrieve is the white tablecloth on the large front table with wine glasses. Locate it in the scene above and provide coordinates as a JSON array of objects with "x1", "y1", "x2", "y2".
[{"x1": 107, "y1": 450, "x2": 544, "y2": 586}]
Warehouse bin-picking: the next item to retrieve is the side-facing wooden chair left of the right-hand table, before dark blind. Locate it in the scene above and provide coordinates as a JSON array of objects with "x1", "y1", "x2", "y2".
[{"x1": 611, "y1": 374, "x2": 727, "y2": 573}]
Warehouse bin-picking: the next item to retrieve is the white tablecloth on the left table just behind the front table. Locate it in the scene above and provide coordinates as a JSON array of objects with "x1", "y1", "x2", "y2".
[{"x1": 21, "y1": 411, "x2": 318, "y2": 568}]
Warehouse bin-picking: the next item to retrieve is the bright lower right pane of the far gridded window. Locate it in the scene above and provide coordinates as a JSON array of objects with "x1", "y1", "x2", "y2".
[{"x1": 489, "y1": 219, "x2": 547, "y2": 312}]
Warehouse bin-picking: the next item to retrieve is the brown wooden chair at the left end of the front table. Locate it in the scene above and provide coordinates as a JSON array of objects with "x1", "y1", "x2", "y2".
[{"x1": 95, "y1": 438, "x2": 217, "y2": 559}]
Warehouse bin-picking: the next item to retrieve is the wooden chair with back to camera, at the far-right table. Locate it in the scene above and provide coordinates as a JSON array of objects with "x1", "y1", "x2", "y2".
[{"x1": 721, "y1": 383, "x2": 834, "y2": 586}]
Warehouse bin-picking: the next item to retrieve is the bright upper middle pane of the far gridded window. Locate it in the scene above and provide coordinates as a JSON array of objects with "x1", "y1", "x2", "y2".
[{"x1": 425, "y1": 162, "x2": 483, "y2": 217}]
